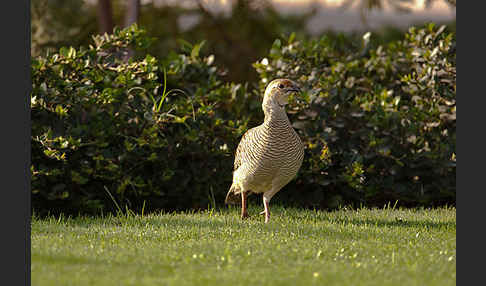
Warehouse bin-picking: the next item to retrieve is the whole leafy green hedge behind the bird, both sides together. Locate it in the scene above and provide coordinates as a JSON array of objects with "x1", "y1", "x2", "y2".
[{"x1": 31, "y1": 25, "x2": 456, "y2": 214}]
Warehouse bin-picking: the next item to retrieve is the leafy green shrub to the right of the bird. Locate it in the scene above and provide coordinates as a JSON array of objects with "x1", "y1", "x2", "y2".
[{"x1": 254, "y1": 24, "x2": 456, "y2": 207}]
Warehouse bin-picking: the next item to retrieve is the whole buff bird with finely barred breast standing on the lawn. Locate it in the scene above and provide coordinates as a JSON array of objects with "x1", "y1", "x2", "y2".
[{"x1": 225, "y1": 79, "x2": 304, "y2": 223}]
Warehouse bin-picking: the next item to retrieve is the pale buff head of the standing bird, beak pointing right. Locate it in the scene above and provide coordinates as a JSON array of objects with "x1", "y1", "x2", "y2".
[{"x1": 263, "y1": 79, "x2": 300, "y2": 110}]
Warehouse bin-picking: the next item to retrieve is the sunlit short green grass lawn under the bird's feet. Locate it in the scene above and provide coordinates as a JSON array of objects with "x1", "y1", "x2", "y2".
[{"x1": 31, "y1": 206, "x2": 456, "y2": 286}]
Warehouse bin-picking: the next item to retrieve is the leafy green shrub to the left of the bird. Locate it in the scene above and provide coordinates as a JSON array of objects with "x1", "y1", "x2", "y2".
[{"x1": 31, "y1": 26, "x2": 251, "y2": 213}]
